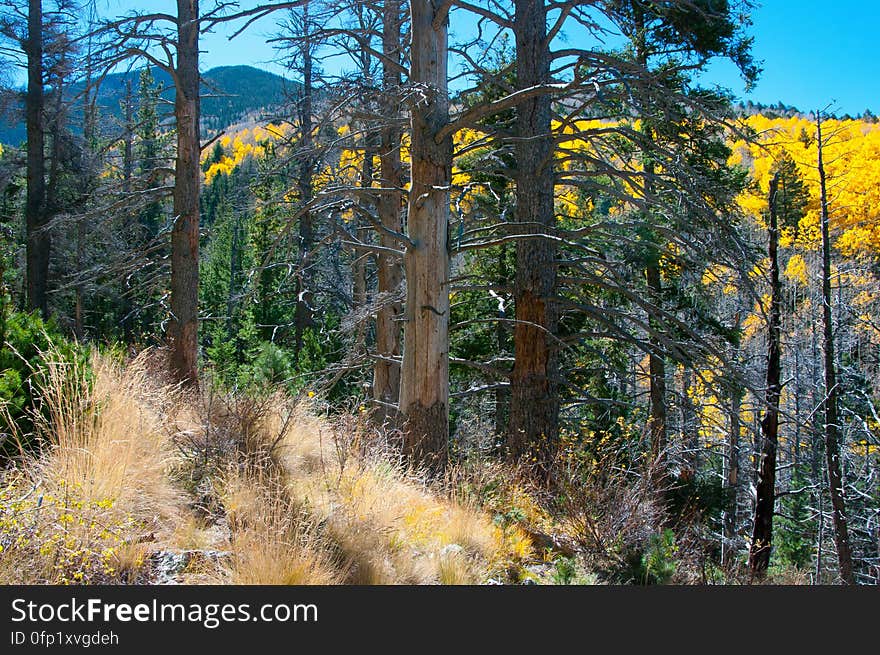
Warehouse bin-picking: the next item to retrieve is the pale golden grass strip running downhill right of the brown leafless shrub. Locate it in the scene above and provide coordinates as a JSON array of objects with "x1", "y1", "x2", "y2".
[{"x1": 254, "y1": 408, "x2": 531, "y2": 584}]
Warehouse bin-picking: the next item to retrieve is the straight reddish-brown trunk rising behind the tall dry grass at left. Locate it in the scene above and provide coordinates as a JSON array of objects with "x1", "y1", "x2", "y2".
[{"x1": 167, "y1": 0, "x2": 201, "y2": 385}]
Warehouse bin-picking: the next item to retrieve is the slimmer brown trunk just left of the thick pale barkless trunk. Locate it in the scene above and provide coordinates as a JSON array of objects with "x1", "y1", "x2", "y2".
[{"x1": 373, "y1": 0, "x2": 403, "y2": 423}]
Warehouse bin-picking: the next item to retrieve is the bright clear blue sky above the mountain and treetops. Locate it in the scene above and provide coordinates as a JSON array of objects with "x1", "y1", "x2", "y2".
[{"x1": 102, "y1": 0, "x2": 880, "y2": 115}]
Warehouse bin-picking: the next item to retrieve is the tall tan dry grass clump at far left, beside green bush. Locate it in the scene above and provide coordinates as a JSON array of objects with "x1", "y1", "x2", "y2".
[{"x1": 0, "y1": 353, "x2": 183, "y2": 583}]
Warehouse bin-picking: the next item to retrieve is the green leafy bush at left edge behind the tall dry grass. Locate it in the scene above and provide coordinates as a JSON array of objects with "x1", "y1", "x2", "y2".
[{"x1": 0, "y1": 312, "x2": 86, "y2": 457}]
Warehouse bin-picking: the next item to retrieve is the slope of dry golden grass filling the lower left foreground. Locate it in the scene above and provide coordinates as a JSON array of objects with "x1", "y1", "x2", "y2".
[{"x1": 0, "y1": 353, "x2": 550, "y2": 584}]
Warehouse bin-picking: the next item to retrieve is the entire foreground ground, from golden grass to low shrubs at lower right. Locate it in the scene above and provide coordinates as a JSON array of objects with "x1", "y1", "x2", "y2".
[{"x1": 0, "y1": 351, "x2": 805, "y2": 585}]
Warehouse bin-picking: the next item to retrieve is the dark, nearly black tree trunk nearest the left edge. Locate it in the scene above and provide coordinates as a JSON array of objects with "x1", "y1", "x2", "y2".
[{"x1": 25, "y1": 0, "x2": 51, "y2": 318}]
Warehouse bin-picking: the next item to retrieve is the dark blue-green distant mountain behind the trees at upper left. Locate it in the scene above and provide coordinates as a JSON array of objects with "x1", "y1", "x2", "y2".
[{"x1": 0, "y1": 66, "x2": 299, "y2": 145}]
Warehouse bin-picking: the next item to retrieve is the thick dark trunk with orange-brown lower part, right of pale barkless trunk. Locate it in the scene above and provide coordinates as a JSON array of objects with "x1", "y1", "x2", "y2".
[{"x1": 507, "y1": 0, "x2": 559, "y2": 473}]
